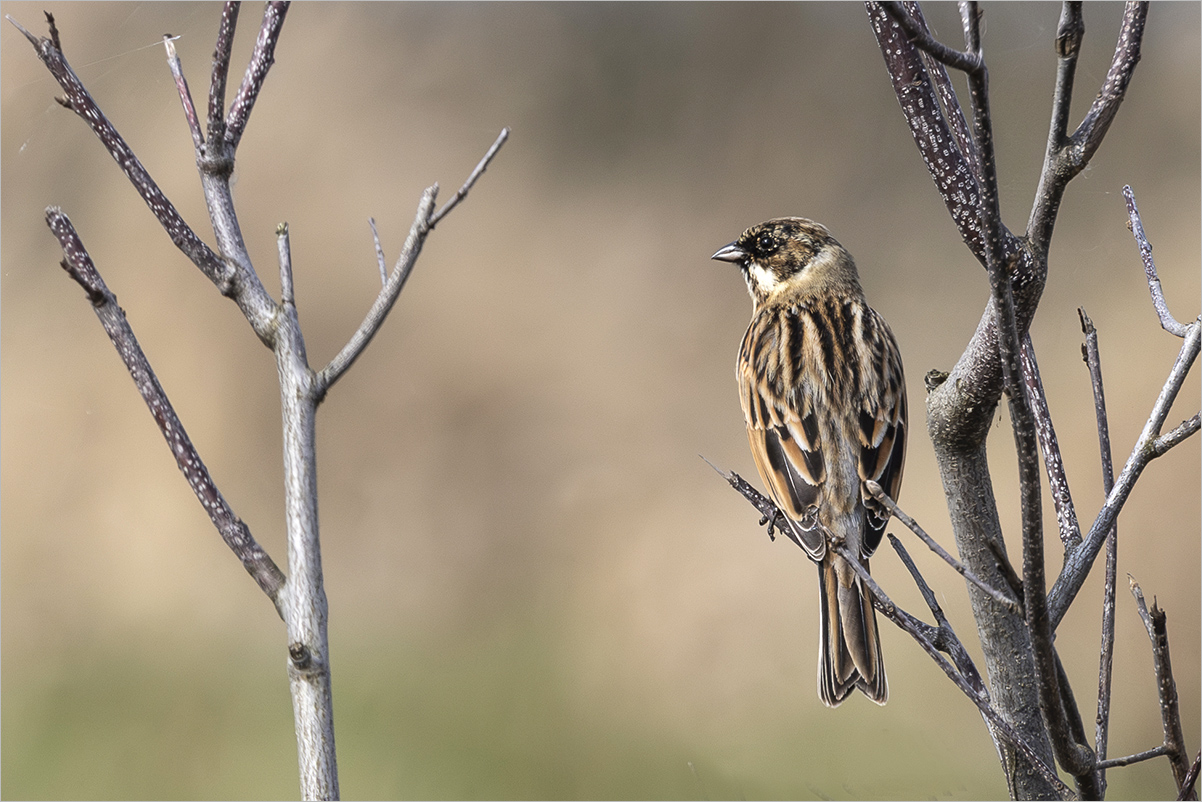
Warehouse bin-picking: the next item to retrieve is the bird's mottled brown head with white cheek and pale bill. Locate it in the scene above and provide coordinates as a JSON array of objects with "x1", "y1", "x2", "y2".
[{"x1": 712, "y1": 218, "x2": 859, "y2": 308}]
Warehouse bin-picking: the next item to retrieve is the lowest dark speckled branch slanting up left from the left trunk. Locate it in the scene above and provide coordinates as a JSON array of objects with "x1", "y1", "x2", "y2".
[{"x1": 46, "y1": 207, "x2": 286, "y2": 618}]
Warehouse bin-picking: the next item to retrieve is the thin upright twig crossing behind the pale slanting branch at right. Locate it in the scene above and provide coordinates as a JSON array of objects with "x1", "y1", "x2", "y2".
[{"x1": 1077, "y1": 308, "x2": 1119, "y2": 794}]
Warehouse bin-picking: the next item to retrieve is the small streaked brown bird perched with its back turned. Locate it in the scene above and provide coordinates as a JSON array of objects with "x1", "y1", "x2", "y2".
[{"x1": 713, "y1": 218, "x2": 906, "y2": 707}]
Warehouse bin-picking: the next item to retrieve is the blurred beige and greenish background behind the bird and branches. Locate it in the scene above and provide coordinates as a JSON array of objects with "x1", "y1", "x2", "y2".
[{"x1": 0, "y1": 2, "x2": 1200, "y2": 798}]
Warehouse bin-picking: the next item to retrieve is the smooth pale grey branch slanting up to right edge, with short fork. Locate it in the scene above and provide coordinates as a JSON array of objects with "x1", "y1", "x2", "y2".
[{"x1": 1048, "y1": 319, "x2": 1202, "y2": 630}]
